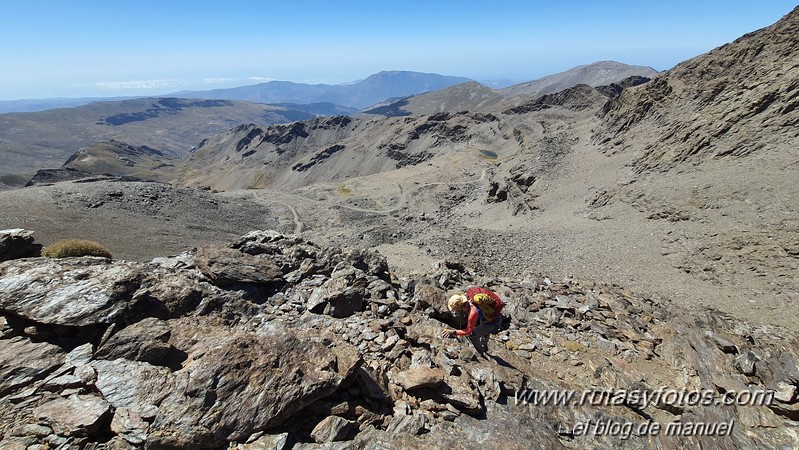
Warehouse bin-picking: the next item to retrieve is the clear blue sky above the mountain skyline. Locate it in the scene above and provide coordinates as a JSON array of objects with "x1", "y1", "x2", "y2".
[{"x1": 0, "y1": 0, "x2": 796, "y2": 100}]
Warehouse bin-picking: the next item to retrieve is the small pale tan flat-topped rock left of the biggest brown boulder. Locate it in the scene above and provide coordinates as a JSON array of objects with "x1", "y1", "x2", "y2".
[{"x1": 33, "y1": 395, "x2": 111, "y2": 437}]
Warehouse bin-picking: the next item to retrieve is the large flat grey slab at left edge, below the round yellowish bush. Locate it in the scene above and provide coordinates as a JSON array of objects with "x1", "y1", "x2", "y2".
[{"x1": 0, "y1": 257, "x2": 144, "y2": 326}]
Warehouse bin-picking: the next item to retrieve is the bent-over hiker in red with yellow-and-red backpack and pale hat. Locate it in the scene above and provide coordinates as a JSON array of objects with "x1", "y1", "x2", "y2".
[{"x1": 441, "y1": 287, "x2": 505, "y2": 353}]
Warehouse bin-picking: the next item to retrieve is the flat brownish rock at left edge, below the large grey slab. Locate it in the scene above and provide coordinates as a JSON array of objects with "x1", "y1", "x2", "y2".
[{"x1": 0, "y1": 336, "x2": 64, "y2": 396}]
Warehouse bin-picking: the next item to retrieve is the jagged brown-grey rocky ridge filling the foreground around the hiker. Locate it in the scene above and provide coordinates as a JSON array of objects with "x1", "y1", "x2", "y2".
[{"x1": 0, "y1": 231, "x2": 799, "y2": 449}]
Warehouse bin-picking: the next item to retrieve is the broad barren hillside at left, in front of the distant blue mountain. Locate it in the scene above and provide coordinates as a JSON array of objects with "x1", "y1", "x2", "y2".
[{"x1": 0, "y1": 98, "x2": 313, "y2": 186}]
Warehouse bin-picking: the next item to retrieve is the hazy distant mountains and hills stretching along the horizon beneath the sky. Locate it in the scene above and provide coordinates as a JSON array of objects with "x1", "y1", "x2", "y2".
[{"x1": 0, "y1": 63, "x2": 655, "y2": 185}]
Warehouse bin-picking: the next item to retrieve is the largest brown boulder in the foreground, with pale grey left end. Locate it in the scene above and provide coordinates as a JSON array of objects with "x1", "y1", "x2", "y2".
[{"x1": 92, "y1": 322, "x2": 360, "y2": 448}]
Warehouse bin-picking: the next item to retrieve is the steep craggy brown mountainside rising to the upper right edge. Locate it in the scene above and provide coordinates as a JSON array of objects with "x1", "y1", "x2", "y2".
[{"x1": 596, "y1": 9, "x2": 799, "y2": 172}]
